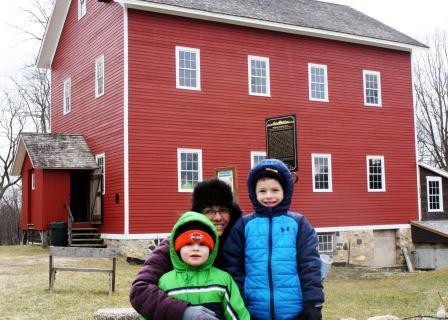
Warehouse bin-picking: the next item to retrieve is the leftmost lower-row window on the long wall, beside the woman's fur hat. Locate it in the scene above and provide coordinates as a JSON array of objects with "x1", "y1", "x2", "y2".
[{"x1": 177, "y1": 149, "x2": 202, "y2": 192}]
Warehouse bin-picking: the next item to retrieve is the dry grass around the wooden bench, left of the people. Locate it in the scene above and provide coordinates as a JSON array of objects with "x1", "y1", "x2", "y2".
[{"x1": 0, "y1": 246, "x2": 140, "y2": 320}]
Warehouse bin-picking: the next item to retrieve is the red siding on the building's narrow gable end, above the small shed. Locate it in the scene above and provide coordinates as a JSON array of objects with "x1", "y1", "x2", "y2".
[{"x1": 51, "y1": 0, "x2": 124, "y2": 233}]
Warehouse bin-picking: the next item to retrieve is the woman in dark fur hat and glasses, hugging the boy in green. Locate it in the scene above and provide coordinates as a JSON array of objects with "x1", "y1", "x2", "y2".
[{"x1": 130, "y1": 179, "x2": 241, "y2": 320}]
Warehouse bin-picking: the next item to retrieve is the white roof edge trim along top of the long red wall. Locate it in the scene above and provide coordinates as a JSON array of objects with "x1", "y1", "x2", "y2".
[{"x1": 115, "y1": 0, "x2": 427, "y2": 52}]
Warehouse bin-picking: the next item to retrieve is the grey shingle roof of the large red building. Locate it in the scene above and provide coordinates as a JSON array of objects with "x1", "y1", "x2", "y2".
[{"x1": 142, "y1": 0, "x2": 426, "y2": 47}]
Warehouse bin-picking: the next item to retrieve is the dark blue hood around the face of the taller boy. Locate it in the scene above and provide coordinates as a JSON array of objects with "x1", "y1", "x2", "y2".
[{"x1": 247, "y1": 159, "x2": 294, "y2": 215}]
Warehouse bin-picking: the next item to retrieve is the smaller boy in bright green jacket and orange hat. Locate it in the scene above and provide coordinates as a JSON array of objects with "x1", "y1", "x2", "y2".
[{"x1": 141, "y1": 212, "x2": 250, "y2": 320}]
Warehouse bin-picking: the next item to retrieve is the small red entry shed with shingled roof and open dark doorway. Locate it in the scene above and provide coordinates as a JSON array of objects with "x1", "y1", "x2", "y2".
[{"x1": 12, "y1": 133, "x2": 101, "y2": 236}]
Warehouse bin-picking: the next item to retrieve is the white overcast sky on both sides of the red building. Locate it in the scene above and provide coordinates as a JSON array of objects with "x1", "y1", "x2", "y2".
[{"x1": 0, "y1": 0, "x2": 448, "y2": 84}]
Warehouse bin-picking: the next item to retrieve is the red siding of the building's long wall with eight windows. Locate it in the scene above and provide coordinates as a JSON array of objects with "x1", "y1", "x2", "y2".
[{"x1": 127, "y1": 10, "x2": 418, "y2": 233}]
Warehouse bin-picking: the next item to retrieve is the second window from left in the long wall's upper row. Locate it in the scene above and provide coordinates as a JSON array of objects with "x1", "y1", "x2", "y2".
[{"x1": 248, "y1": 56, "x2": 271, "y2": 97}]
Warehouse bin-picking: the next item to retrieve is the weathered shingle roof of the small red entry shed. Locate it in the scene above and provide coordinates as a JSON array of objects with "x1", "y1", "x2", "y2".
[{"x1": 11, "y1": 133, "x2": 98, "y2": 176}]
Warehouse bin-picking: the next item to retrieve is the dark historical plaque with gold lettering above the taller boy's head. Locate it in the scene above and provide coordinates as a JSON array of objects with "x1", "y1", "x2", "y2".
[{"x1": 266, "y1": 114, "x2": 298, "y2": 171}]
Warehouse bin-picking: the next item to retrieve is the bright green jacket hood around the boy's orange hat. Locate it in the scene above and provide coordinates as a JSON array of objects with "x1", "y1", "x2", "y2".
[{"x1": 170, "y1": 211, "x2": 219, "y2": 271}]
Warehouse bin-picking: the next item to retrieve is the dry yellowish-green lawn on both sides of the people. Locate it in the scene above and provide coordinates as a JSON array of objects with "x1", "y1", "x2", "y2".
[{"x1": 0, "y1": 246, "x2": 448, "y2": 320}]
